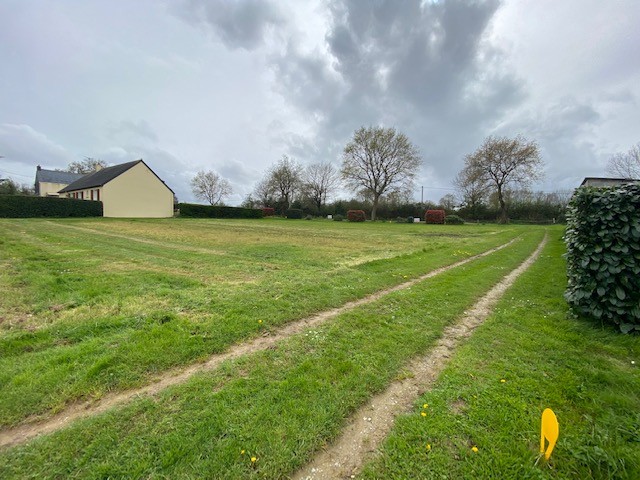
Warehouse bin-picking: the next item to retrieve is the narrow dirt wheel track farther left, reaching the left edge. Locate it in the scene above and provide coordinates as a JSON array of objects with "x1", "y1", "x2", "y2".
[{"x1": 0, "y1": 239, "x2": 516, "y2": 448}]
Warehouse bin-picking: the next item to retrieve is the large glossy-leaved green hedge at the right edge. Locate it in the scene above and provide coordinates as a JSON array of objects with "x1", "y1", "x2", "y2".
[{"x1": 565, "y1": 185, "x2": 640, "y2": 333}]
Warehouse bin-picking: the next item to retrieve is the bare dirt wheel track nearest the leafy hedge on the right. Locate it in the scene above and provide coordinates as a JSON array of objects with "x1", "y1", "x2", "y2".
[{"x1": 293, "y1": 235, "x2": 547, "y2": 480}]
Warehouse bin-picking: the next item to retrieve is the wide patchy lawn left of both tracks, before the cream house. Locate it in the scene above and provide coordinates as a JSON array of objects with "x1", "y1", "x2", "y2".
[{"x1": 0, "y1": 219, "x2": 529, "y2": 426}]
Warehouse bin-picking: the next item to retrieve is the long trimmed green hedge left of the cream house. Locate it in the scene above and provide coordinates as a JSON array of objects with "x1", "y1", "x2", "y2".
[{"x1": 0, "y1": 195, "x2": 102, "y2": 218}]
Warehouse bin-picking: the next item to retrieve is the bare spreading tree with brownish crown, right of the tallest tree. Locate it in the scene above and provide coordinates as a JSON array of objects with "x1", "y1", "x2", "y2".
[{"x1": 464, "y1": 135, "x2": 543, "y2": 223}]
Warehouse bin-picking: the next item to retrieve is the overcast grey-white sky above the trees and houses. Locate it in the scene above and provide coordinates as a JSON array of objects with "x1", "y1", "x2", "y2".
[{"x1": 0, "y1": 0, "x2": 640, "y2": 205}]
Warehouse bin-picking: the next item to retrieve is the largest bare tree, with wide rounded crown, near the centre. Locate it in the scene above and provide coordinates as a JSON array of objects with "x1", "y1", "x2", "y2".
[{"x1": 341, "y1": 127, "x2": 422, "y2": 220}]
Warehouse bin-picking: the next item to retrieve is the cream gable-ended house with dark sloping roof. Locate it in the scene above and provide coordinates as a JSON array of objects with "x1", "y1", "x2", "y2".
[{"x1": 58, "y1": 160, "x2": 174, "y2": 218}]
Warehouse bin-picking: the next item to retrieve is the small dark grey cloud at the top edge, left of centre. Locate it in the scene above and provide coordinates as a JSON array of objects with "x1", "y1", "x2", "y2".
[{"x1": 180, "y1": 0, "x2": 286, "y2": 50}]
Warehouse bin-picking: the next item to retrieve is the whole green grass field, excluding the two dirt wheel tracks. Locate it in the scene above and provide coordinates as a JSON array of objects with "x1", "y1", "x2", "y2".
[{"x1": 0, "y1": 219, "x2": 640, "y2": 478}]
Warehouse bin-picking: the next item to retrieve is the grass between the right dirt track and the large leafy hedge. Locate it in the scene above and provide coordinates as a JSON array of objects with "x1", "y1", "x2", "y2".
[{"x1": 361, "y1": 231, "x2": 640, "y2": 480}]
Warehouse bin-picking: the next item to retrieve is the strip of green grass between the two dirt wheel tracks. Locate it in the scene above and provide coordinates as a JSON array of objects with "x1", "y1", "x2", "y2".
[{"x1": 0, "y1": 229, "x2": 543, "y2": 479}]
